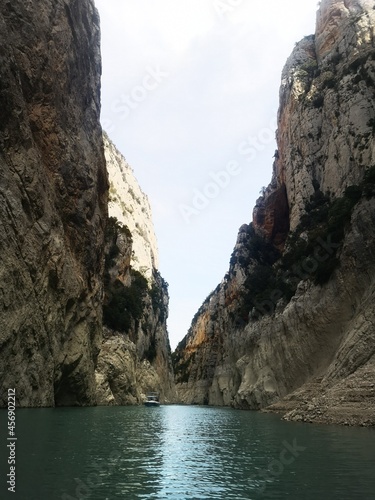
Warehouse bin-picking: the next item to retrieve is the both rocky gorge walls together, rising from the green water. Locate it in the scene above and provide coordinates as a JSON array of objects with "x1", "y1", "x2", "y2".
[{"x1": 0, "y1": 0, "x2": 375, "y2": 432}]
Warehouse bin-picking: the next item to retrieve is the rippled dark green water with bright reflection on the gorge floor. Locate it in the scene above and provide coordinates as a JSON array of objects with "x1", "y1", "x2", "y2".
[{"x1": 0, "y1": 406, "x2": 375, "y2": 500}]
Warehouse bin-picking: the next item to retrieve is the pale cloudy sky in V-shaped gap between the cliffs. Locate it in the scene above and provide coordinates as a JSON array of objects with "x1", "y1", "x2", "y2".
[{"x1": 95, "y1": 0, "x2": 317, "y2": 349}]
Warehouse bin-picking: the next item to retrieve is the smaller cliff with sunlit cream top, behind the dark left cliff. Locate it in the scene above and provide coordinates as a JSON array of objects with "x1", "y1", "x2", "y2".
[{"x1": 96, "y1": 135, "x2": 176, "y2": 405}]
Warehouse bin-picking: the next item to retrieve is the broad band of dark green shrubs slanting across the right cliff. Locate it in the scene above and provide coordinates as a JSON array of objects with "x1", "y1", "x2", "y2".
[{"x1": 238, "y1": 178, "x2": 375, "y2": 319}]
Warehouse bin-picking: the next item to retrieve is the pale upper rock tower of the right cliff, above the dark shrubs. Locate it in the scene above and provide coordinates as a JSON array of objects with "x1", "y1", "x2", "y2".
[{"x1": 276, "y1": 0, "x2": 375, "y2": 230}]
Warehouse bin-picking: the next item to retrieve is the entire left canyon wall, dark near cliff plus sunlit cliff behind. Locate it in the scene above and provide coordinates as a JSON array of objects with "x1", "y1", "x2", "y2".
[{"x1": 0, "y1": 0, "x2": 174, "y2": 407}]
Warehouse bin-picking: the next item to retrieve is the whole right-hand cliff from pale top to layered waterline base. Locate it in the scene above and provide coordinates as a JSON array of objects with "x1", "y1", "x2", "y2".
[{"x1": 173, "y1": 0, "x2": 375, "y2": 425}]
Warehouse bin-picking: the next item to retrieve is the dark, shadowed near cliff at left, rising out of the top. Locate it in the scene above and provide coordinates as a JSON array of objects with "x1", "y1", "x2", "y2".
[{"x1": 0, "y1": 0, "x2": 108, "y2": 406}]
